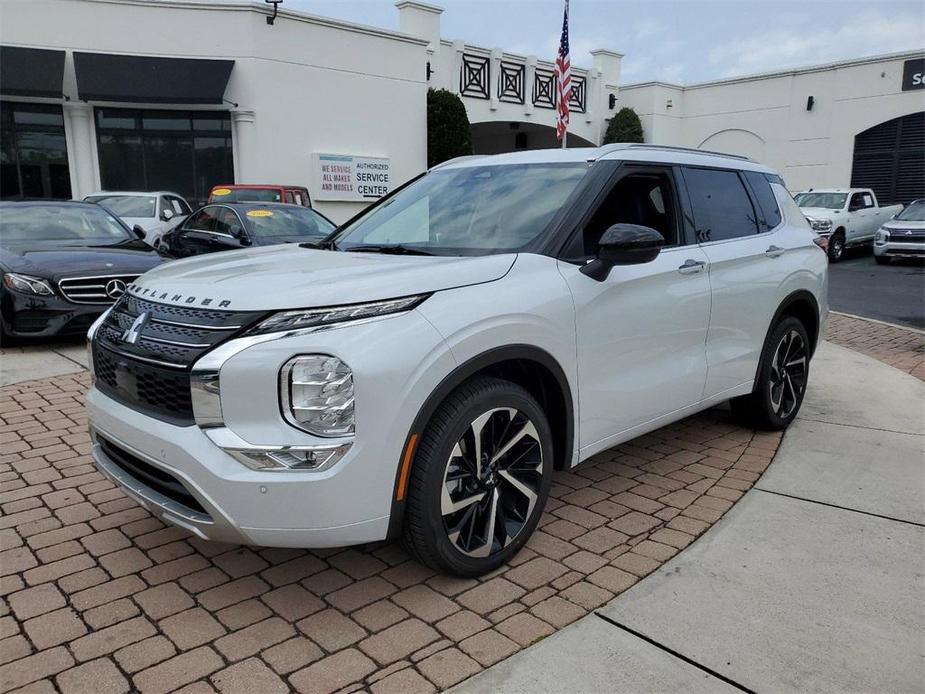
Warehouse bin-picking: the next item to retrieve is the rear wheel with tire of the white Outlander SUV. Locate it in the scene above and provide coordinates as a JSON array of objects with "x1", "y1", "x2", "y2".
[{"x1": 730, "y1": 316, "x2": 810, "y2": 431}]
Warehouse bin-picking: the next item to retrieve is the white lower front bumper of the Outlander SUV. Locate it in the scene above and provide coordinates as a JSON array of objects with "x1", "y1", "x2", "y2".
[{"x1": 87, "y1": 388, "x2": 388, "y2": 547}]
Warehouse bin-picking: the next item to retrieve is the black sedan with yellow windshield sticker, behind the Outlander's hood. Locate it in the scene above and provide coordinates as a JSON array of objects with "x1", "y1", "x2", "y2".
[{"x1": 158, "y1": 202, "x2": 335, "y2": 258}]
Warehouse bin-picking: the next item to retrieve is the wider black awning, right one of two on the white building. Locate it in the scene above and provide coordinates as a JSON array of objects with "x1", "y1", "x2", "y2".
[{"x1": 74, "y1": 52, "x2": 234, "y2": 104}]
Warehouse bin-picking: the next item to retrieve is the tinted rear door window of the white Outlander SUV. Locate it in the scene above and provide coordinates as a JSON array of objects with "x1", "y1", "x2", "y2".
[{"x1": 684, "y1": 169, "x2": 758, "y2": 243}]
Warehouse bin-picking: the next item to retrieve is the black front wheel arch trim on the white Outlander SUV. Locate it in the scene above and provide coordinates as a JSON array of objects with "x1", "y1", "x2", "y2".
[{"x1": 388, "y1": 344, "x2": 575, "y2": 538}]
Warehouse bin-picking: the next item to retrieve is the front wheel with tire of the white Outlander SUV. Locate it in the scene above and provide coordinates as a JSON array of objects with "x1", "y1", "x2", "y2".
[{"x1": 403, "y1": 377, "x2": 553, "y2": 576}]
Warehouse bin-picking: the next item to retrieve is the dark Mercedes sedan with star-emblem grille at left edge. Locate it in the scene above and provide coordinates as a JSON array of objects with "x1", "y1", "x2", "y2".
[{"x1": 0, "y1": 201, "x2": 161, "y2": 339}]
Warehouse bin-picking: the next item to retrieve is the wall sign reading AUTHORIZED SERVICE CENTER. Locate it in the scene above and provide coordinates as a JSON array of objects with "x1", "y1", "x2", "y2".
[{"x1": 312, "y1": 153, "x2": 392, "y2": 202}]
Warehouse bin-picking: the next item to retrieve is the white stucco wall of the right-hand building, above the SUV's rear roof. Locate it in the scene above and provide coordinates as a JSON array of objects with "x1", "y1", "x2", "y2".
[{"x1": 618, "y1": 52, "x2": 925, "y2": 190}]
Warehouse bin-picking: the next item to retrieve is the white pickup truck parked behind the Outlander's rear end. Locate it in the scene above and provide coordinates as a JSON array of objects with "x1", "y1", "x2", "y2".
[{"x1": 794, "y1": 188, "x2": 903, "y2": 263}]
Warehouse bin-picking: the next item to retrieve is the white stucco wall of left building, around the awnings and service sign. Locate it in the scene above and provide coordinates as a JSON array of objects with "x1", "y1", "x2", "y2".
[{"x1": 0, "y1": 0, "x2": 427, "y2": 220}]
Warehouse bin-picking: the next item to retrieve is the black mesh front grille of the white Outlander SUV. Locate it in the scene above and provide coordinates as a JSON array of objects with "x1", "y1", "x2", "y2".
[{"x1": 93, "y1": 294, "x2": 264, "y2": 426}]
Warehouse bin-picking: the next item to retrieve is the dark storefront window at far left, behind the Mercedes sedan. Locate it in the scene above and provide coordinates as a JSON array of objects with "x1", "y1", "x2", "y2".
[{"x1": 0, "y1": 101, "x2": 71, "y2": 200}]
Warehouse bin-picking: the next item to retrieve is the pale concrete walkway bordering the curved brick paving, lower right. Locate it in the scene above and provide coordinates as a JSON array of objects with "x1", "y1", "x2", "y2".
[{"x1": 453, "y1": 343, "x2": 925, "y2": 692}]
